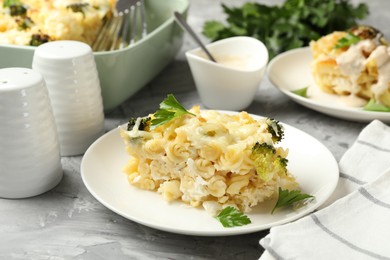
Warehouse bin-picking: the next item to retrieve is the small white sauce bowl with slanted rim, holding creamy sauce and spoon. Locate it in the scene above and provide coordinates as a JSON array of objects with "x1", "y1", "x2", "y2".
[{"x1": 186, "y1": 36, "x2": 268, "y2": 111}]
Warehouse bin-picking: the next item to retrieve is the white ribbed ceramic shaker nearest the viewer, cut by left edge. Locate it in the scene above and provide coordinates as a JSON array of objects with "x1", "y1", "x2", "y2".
[{"x1": 0, "y1": 68, "x2": 63, "y2": 198}]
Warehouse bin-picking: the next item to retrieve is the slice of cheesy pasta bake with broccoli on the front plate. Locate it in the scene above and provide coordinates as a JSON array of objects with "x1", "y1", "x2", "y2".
[{"x1": 120, "y1": 95, "x2": 307, "y2": 221}]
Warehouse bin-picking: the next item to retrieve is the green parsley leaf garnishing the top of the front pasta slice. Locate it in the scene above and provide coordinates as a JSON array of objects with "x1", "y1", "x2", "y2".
[{"x1": 151, "y1": 94, "x2": 195, "y2": 129}]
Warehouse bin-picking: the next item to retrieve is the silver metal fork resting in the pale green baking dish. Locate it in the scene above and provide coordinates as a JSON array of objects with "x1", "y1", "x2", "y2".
[{"x1": 92, "y1": 0, "x2": 147, "y2": 51}]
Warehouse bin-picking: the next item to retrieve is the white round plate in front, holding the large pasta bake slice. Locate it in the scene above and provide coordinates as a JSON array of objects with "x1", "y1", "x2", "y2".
[{"x1": 81, "y1": 112, "x2": 339, "y2": 236}]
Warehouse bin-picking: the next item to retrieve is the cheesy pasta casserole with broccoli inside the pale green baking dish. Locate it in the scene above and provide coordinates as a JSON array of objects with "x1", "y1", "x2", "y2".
[{"x1": 0, "y1": 0, "x2": 115, "y2": 46}]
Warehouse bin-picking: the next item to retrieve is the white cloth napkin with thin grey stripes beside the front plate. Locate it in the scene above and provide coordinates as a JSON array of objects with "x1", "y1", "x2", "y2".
[{"x1": 260, "y1": 120, "x2": 390, "y2": 259}]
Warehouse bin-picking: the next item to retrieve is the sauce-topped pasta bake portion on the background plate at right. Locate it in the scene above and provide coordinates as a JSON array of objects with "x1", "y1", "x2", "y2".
[{"x1": 310, "y1": 26, "x2": 390, "y2": 107}]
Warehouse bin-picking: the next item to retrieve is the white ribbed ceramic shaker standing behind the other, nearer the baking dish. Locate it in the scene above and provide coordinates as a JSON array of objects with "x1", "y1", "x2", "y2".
[{"x1": 32, "y1": 41, "x2": 104, "y2": 156}]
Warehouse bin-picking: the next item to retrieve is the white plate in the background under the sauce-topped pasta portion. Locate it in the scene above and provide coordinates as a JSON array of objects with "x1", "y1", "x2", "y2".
[{"x1": 267, "y1": 47, "x2": 390, "y2": 122}]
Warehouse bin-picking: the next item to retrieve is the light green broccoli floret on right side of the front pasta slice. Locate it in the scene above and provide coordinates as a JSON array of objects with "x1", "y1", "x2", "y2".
[{"x1": 251, "y1": 143, "x2": 288, "y2": 181}]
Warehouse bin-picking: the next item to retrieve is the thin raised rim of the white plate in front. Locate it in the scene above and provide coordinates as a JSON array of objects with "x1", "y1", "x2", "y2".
[{"x1": 80, "y1": 110, "x2": 339, "y2": 236}]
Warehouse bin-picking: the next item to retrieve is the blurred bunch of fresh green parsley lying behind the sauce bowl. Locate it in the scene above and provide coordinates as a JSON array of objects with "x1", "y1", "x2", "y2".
[{"x1": 203, "y1": 0, "x2": 369, "y2": 58}]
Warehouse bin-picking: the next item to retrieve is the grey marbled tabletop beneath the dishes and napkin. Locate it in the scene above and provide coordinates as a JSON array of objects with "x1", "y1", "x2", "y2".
[{"x1": 0, "y1": 0, "x2": 390, "y2": 260}]
